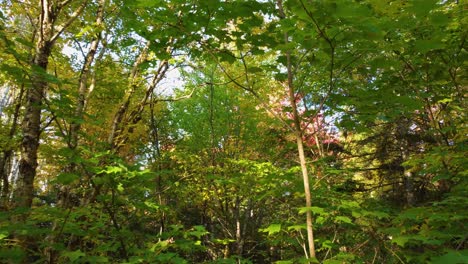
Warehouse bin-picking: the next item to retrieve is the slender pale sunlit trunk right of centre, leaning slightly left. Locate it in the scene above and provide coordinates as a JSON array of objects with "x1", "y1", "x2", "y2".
[{"x1": 277, "y1": 0, "x2": 315, "y2": 258}]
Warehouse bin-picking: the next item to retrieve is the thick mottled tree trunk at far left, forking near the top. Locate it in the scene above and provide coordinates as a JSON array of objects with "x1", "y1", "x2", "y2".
[{"x1": 13, "y1": 0, "x2": 87, "y2": 208}]
